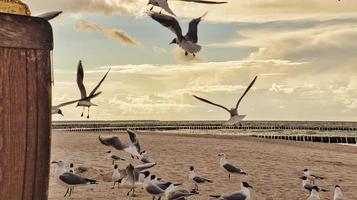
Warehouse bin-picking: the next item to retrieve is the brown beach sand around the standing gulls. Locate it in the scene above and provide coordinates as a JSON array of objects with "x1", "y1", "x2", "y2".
[{"x1": 49, "y1": 131, "x2": 357, "y2": 200}]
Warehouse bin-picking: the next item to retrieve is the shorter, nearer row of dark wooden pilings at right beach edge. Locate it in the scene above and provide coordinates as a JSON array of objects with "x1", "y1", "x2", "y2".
[{"x1": 254, "y1": 135, "x2": 357, "y2": 144}]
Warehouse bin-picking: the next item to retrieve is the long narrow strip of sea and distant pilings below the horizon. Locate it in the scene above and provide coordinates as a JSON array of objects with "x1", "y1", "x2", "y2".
[{"x1": 52, "y1": 121, "x2": 357, "y2": 132}]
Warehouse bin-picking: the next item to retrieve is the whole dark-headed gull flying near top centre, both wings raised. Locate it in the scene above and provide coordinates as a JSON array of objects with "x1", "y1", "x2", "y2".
[{"x1": 149, "y1": 12, "x2": 207, "y2": 56}]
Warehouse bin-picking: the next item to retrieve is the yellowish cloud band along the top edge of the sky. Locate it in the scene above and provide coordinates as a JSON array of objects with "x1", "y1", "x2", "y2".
[{"x1": 27, "y1": 0, "x2": 357, "y2": 22}]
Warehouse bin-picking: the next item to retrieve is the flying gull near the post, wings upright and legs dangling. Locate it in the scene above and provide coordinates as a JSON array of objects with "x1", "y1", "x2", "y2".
[{"x1": 77, "y1": 60, "x2": 110, "y2": 119}]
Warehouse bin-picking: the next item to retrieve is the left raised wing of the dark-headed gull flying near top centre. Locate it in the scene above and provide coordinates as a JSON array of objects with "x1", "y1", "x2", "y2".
[{"x1": 149, "y1": 12, "x2": 182, "y2": 39}]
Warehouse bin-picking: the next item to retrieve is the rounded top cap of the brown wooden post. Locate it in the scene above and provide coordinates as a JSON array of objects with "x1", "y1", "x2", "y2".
[{"x1": 0, "y1": 13, "x2": 53, "y2": 50}]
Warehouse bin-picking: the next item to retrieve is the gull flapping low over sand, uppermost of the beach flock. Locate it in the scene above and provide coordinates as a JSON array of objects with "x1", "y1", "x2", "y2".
[{"x1": 98, "y1": 130, "x2": 142, "y2": 158}]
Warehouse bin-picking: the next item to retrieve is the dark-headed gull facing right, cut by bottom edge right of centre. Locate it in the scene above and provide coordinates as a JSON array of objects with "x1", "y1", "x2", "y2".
[{"x1": 209, "y1": 182, "x2": 253, "y2": 200}]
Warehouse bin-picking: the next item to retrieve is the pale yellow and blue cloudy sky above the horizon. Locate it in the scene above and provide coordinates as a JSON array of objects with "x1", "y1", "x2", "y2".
[{"x1": 24, "y1": 0, "x2": 357, "y2": 121}]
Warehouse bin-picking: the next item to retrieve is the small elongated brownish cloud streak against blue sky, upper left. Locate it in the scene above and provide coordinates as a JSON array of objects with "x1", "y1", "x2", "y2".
[{"x1": 75, "y1": 20, "x2": 141, "y2": 47}]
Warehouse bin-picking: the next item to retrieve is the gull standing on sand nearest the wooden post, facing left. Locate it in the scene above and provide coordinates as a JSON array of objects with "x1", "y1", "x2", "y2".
[{"x1": 52, "y1": 161, "x2": 97, "y2": 197}]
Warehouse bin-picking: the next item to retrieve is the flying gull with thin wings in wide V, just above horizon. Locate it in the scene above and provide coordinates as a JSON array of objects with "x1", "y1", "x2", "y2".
[{"x1": 193, "y1": 76, "x2": 258, "y2": 124}]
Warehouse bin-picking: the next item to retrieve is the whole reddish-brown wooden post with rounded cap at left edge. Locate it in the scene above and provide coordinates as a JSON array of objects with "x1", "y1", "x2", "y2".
[{"x1": 0, "y1": 13, "x2": 53, "y2": 200}]
